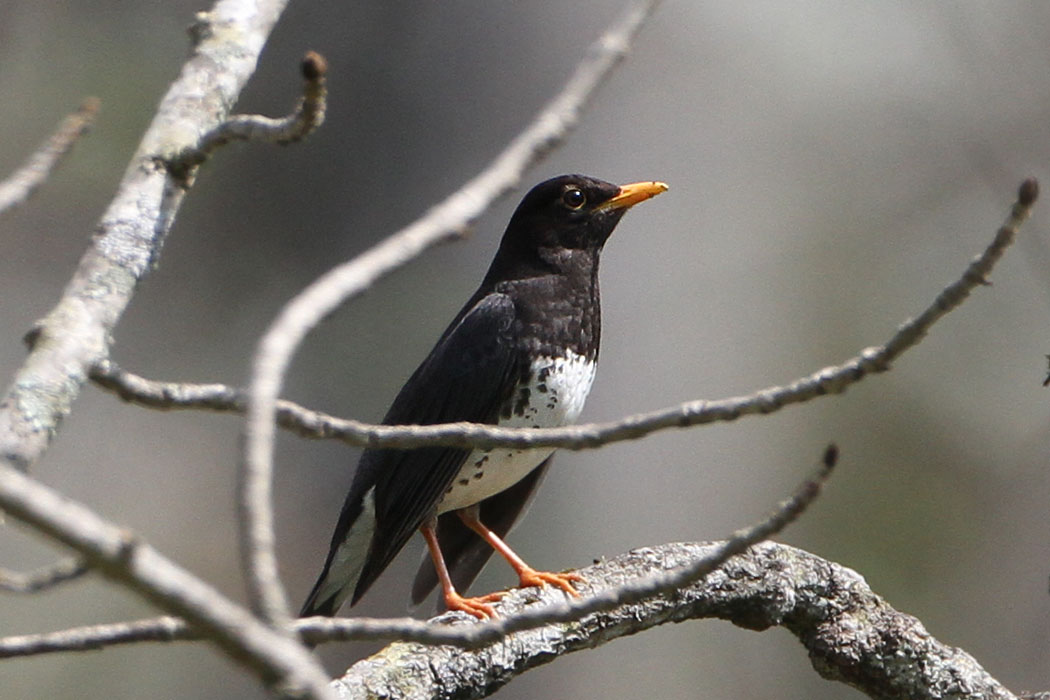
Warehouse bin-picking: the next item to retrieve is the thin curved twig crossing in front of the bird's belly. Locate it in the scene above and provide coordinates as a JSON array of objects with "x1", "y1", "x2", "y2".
[{"x1": 91, "y1": 179, "x2": 1038, "y2": 449}]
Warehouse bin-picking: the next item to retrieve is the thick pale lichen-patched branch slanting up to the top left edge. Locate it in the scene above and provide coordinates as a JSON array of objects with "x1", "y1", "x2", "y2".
[{"x1": 0, "y1": 0, "x2": 319, "y2": 476}]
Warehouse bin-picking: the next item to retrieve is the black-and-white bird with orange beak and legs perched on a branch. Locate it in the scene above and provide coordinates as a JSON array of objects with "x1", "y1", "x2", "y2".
[{"x1": 300, "y1": 174, "x2": 668, "y2": 619}]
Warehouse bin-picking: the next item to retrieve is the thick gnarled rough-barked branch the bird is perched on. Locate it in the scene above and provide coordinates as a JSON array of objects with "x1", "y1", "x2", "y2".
[{"x1": 335, "y1": 543, "x2": 1015, "y2": 700}]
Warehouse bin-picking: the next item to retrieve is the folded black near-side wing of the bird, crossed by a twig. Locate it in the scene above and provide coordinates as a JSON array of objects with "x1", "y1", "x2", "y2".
[{"x1": 352, "y1": 294, "x2": 522, "y2": 602}]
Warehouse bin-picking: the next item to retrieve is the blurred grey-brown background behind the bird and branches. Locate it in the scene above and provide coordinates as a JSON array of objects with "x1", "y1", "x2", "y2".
[{"x1": 0, "y1": 0, "x2": 1050, "y2": 700}]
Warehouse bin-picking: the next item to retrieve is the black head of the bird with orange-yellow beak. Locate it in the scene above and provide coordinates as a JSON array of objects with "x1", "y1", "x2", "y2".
[{"x1": 494, "y1": 175, "x2": 667, "y2": 281}]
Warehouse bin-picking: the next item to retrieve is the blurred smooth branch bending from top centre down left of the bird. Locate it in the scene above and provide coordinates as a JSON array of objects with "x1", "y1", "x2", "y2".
[{"x1": 238, "y1": 0, "x2": 657, "y2": 624}]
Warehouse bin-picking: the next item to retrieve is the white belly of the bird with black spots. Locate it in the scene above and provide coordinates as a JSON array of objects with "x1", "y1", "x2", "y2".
[{"x1": 438, "y1": 352, "x2": 595, "y2": 513}]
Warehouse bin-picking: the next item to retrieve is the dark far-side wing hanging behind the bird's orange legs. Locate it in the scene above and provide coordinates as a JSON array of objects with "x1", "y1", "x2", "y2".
[{"x1": 412, "y1": 457, "x2": 553, "y2": 606}]
